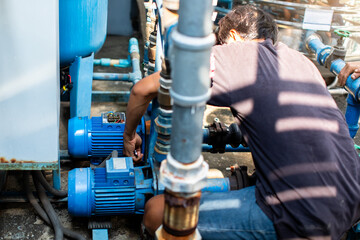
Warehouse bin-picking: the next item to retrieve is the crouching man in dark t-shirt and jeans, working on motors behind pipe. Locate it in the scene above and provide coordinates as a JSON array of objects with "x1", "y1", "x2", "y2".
[{"x1": 124, "y1": 6, "x2": 360, "y2": 240}]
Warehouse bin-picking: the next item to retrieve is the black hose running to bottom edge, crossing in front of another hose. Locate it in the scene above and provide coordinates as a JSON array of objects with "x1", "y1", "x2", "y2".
[{"x1": 33, "y1": 171, "x2": 64, "y2": 240}]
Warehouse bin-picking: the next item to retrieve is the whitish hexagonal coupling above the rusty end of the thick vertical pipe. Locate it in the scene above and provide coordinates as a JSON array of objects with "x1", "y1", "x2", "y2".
[{"x1": 160, "y1": 153, "x2": 209, "y2": 193}]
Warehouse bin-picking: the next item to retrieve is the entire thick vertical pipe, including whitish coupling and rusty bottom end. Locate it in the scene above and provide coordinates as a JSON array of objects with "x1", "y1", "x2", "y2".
[{"x1": 156, "y1": 0, "x2": 215, "y2": 239}]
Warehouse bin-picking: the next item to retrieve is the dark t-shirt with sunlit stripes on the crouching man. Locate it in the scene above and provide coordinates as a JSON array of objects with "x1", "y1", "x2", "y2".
[{"x1": 209, "y1": 40, "x2": 360, "y2": 239}]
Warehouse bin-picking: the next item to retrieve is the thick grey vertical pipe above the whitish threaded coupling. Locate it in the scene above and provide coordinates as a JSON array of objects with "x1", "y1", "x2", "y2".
[{"x1": 171, "y1": 0, "x2": 214, "y2": 163}]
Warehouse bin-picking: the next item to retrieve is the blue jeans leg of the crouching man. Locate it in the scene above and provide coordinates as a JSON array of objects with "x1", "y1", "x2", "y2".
[{"x1": 198, "y1": 186, "x2": 276, "y2": 240}]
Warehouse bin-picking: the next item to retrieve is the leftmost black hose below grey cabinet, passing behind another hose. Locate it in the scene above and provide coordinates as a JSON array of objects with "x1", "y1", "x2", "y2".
[{"x1": 24, "y1": 171, "x2": 86, "y2": 240}]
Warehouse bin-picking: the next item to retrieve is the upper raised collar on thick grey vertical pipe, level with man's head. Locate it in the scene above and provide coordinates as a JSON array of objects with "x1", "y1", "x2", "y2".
[{"x1": 171, "y1": 29, "x2": 215, "y2": 51}]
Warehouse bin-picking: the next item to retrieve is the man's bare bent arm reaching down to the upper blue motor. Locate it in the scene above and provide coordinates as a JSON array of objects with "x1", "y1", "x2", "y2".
[{"x1": 124, "y1": 72, "x2": 160, "y2": 162}]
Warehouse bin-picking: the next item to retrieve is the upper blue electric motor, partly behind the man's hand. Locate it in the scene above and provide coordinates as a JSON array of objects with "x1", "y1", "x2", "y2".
[{"x1": 68, "y1": 112, "x2": 145, "y2": 159}]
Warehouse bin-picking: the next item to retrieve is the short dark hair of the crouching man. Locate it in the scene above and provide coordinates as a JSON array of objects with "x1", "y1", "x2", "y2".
[{"x1": 217, "y1": 5, "x2": 278, "y2": 44}]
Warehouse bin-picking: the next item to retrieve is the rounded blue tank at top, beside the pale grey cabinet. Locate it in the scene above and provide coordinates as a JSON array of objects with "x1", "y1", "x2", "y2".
[{"x1": 59, "y1": 0, "x2": 108, "y2": 66}]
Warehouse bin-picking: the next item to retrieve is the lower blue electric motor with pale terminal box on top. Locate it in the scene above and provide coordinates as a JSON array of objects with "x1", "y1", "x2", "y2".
[{"x1": 68, "y1": 157, "x2": 154, "y2": 217}]
